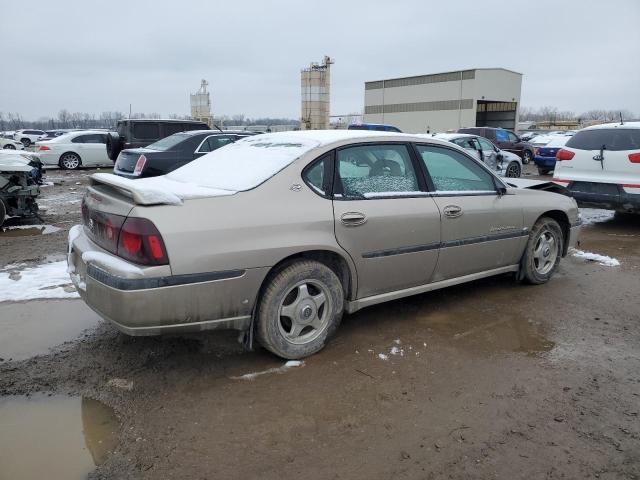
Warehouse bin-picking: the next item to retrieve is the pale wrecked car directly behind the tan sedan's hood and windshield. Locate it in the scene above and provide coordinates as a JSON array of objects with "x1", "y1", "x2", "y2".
[{"x1": 433, "y1": 133, "x2": 522, "y2": 178}]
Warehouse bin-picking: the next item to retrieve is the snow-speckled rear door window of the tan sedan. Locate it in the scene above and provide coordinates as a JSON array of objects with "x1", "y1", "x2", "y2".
[{"x1": 337, "y1": 145, "x2": 420, "y2": 199}]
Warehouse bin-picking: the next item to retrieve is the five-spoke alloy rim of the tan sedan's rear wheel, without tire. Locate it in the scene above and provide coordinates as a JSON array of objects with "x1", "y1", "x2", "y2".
[{"x1": 278, "y1": 280, "x2": 333, "y2": 345}]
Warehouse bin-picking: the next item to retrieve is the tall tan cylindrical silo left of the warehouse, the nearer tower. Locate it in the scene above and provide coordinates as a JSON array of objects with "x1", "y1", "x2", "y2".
[{"x1": 300, "y1": 55, "x2": 333, "y2": 130}]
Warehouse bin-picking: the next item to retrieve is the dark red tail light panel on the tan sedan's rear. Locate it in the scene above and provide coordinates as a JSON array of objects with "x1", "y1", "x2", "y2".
[{"x1": 82, "y1": 202, "x2": 169, "y2": 265}]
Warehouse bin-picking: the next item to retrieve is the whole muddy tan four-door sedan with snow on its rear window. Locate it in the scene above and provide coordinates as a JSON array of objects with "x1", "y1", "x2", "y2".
[{"x1": 68, "y1": 131, "x2": 580, "y2": 359}]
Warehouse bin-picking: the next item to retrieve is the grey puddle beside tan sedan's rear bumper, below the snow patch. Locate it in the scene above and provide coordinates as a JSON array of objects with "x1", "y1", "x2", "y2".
[{"x1": 0, "y1": 300, "x2": 101, "y2": 360}]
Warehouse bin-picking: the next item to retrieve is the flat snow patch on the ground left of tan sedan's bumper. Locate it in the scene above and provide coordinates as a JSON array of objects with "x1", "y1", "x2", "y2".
[{"x1": 0, "y1": 260, "x2": 78, "y2": 302}]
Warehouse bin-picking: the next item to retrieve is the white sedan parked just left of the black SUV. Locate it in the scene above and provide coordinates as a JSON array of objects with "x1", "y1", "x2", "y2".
[{"x1": 36, "y1": 130, "x2": 113, "y2": 170}]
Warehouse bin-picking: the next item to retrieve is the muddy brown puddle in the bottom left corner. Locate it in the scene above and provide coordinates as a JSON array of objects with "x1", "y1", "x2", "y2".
[{"x1": 0, "y1": 395, "x2": 119, "y2": 480}]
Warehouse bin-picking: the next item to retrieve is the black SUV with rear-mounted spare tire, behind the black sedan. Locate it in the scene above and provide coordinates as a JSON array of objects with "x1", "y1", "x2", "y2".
[{"x1": 107, "y1": 119, "x2": 209, "y2": 161}]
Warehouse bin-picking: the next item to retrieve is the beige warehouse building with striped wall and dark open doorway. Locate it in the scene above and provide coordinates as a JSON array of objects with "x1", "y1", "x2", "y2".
[{"x1": 364, "y1": 68, "x2": 522, "y2": 133}]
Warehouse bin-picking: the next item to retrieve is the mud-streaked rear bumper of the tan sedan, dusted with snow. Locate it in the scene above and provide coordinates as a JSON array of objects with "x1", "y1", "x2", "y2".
[{"x1": 68, "y1": 227, "x2": 268, "y2": 335}]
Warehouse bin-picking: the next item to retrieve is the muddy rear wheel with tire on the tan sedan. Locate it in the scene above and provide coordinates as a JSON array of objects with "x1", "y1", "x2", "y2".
[{"x1": 256, "y1": 260, "x2": 344, "y2": 359}]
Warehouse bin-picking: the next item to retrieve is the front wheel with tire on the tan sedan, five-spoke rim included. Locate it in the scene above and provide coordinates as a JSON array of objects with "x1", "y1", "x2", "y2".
[{"x1": 522, "y1": 217, "x2": 564, "y2": 285}]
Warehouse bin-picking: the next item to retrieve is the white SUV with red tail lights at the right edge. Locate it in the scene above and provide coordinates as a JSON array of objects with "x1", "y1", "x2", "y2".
[{"x1": 553, "y1": 122, "x2": 640, "y2": 213}]
